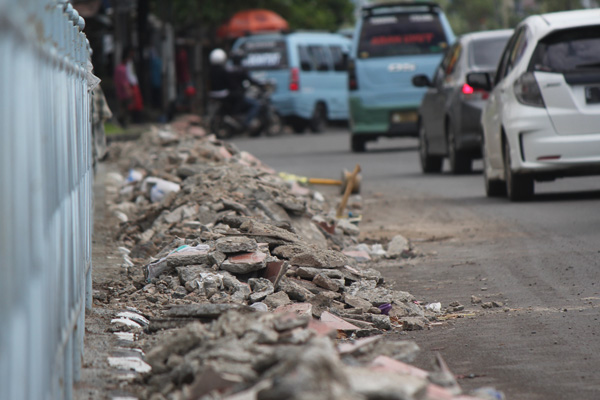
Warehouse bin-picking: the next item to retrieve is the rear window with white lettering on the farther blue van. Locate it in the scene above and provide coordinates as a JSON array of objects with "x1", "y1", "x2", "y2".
[{"x1": 240, "y1": 40, "x2": 288, "y2": 70}]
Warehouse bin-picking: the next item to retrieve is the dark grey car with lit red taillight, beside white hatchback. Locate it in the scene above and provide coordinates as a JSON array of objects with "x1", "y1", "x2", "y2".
[{"x1": 412, "y1": 29, "x2": 513, "y2": 174}]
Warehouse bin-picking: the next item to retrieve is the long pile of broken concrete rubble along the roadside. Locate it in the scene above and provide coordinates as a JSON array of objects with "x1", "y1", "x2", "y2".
[{"x1": 101, "y1": 116, "x2": 504, "y2": 400}]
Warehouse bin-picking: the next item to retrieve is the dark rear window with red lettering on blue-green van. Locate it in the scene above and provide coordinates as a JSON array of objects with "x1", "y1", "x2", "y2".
[{"x1": 358, "y1": 12, "x2": 447, "y2": 58}]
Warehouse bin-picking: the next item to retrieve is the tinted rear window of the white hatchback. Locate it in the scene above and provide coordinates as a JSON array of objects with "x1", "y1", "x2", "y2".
[{"x1": 529, "y1": 25, "x2": 600, "y2": 72}]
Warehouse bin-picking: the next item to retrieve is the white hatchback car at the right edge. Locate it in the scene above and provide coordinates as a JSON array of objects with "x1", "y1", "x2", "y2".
[{"x1": 467, "y1": 9, "x2": 600, "y2": 201}]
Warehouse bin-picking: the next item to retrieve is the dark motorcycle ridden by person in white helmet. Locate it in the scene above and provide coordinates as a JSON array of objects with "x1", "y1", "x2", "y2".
[{"x1": 208, "y1": 82, "x2": 283, "y2": 139}]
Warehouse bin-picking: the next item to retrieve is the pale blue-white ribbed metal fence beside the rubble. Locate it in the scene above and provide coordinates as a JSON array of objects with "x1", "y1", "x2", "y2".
[{"x1": 0, "y1": 0, "x2": 93, "y2": 400}]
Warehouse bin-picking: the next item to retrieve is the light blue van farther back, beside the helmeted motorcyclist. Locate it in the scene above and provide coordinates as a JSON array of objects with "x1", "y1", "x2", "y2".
[{"x1": 233, "y1": 32, "x2": 351, "y2": 133}]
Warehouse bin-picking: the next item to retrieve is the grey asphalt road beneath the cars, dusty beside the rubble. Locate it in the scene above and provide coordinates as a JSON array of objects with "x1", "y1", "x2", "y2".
[{"x1": 233, "y1": 128, "x2": 600, "y2": 400}]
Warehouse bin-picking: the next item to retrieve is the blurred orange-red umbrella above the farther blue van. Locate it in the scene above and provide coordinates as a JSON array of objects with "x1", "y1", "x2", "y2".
[{"x1": 217, "y1": 9, "x2": 289, "y2": 38}]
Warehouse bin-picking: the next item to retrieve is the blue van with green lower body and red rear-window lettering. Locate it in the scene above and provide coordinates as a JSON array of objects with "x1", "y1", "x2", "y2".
[{"x1": 348, "y1": 2, "x2": 455, "y2": 152}]
